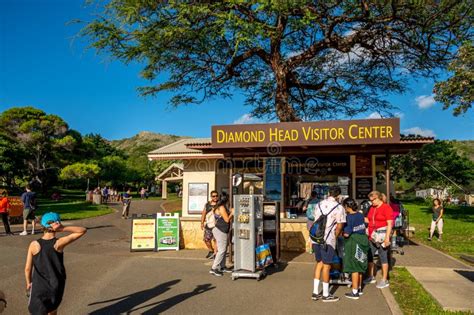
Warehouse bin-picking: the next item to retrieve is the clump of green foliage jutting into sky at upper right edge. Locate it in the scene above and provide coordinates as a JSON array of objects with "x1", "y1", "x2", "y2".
[{"x1": 434, "y1": 41, "x2": 474, "y2": 116}]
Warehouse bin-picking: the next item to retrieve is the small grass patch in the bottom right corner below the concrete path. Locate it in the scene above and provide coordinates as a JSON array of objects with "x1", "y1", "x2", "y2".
[{"x1": 390, "y1": 268, "x2": 472, "y2": 314}]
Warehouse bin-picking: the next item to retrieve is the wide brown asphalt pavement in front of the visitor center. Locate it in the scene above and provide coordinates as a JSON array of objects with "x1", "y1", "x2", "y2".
[{"x1": 0, "y1": 200, "x2": 390, "y2": 315}]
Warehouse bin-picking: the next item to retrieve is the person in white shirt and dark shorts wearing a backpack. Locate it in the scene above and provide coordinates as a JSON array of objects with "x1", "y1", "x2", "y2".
[{"x1": 311, "y1": 186, "x2": 346, "y2": 302}]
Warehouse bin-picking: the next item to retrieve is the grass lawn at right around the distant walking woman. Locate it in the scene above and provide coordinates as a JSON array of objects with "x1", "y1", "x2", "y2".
[{"x1": 403, "y1": 200, "x2": 474, "y2": 258}]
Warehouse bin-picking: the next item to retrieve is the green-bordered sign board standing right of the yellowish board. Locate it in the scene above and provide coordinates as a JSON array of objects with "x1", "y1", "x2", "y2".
[{"x1": 156, "y1": 213, "x2": 179, "y2": 251}]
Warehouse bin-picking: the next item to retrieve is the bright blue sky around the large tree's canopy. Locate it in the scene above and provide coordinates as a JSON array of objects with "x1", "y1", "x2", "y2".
[{"x1": 0, "y1": 0, "x2": 474, "y2": 140}]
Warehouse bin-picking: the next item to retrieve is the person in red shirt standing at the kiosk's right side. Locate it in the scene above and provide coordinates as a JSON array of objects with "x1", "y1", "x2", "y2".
[{"x1": 364, "y1": 191, "x2": 393, "y2": 289}]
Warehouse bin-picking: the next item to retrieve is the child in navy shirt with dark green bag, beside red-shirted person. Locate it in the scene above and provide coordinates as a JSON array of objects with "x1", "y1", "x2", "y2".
[{"x1": 342, "y1": 198, "x2": 369, "y2": 300}]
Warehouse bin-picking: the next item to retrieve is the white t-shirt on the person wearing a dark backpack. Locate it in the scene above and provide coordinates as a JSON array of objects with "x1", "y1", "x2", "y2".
[{"x1": 314, "y1": 197, "x2": 346, "y2": 249}]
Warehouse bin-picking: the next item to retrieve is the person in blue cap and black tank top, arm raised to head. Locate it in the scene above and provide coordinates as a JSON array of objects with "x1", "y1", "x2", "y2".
[{"x1": 25, "y1": 212, "x2": 86, "y2": 314}]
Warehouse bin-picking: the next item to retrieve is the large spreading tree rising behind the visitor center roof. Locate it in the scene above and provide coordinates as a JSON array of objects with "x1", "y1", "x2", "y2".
[{"x1": 82, "y1": 0, "x2": 473, "y2": 121}]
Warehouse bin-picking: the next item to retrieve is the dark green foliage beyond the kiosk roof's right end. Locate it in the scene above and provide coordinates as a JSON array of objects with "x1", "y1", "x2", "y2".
[{"x1": 391, "y1": 140, "x2": 474, "y2": 188}]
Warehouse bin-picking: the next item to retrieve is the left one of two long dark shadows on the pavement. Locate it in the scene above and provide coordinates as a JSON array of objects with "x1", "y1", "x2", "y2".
[{"x1": 88, "y1": 279, "x2": 181, "y2": 314}]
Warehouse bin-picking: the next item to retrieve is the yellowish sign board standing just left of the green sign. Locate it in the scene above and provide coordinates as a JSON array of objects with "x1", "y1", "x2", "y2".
[{"x1": 130, "y1": 217, "x2": 156, "y2": 252}]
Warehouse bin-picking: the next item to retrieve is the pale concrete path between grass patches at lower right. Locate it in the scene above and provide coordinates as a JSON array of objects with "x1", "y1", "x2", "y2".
[{"x1": 395, "y1": 244, "x2": 474, "y2": 312}]
